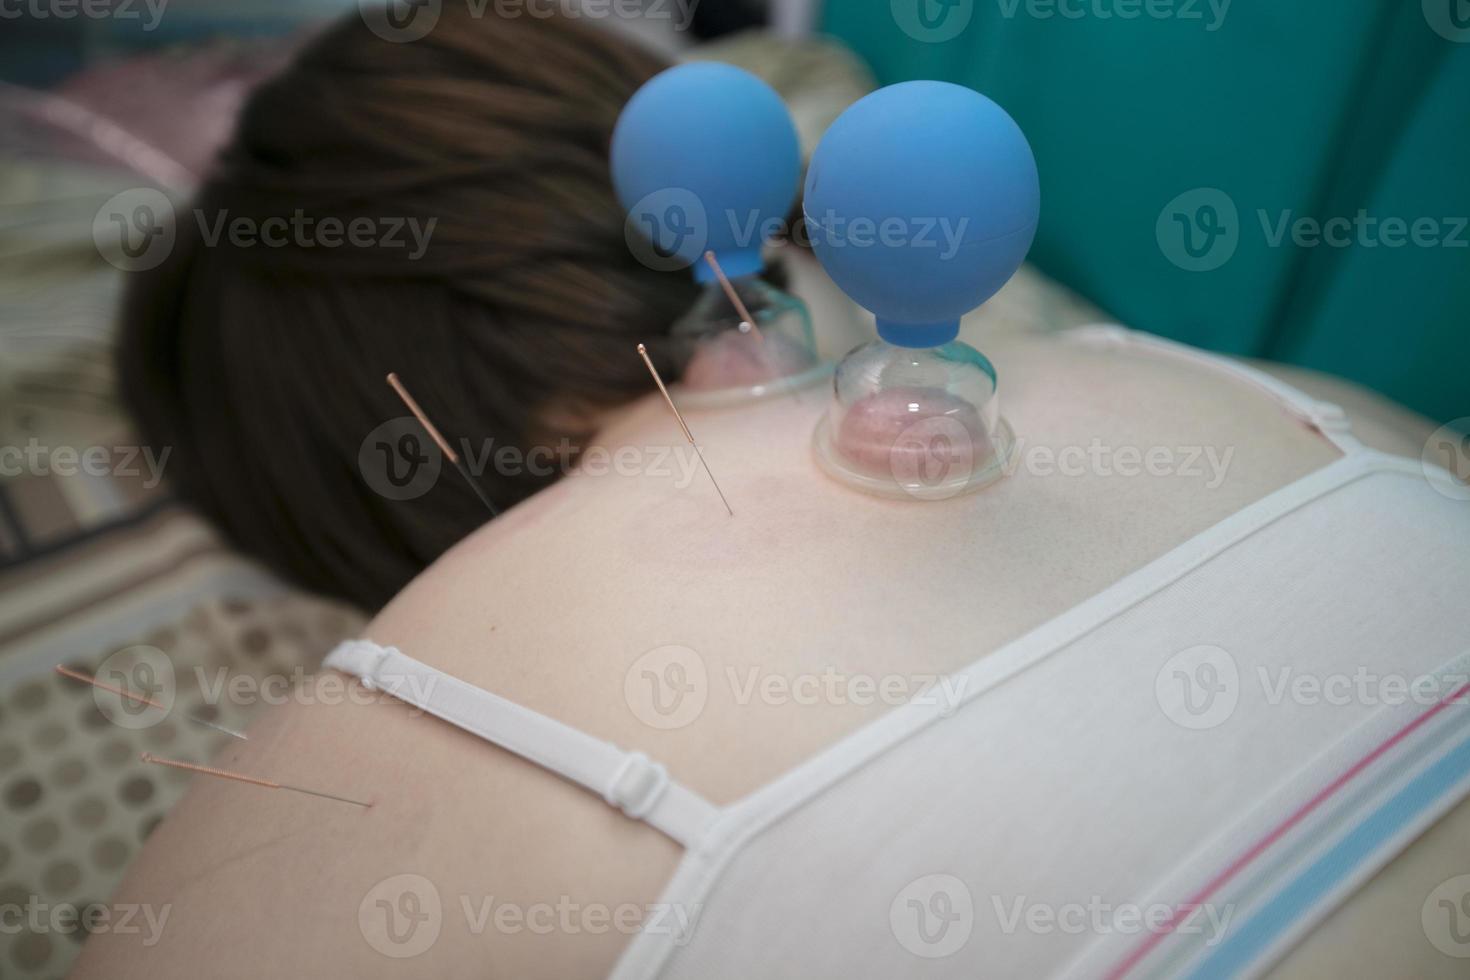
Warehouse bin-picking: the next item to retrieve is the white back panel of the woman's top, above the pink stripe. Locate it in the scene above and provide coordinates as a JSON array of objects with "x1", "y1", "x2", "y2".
[{"x1": 614, "y1": 453, "x2": 1470, "y2": 980}]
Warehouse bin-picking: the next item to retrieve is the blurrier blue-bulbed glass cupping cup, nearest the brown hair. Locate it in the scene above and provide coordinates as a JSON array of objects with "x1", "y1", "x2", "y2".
[{"x1": 612, "y1": 62, "x2": 831, "y2": 407}]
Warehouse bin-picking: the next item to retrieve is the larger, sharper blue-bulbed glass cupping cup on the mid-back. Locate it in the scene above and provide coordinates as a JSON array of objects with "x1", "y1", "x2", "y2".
[{"x1": 804, "y1": 82, "x2": 1039, "y2": 500}]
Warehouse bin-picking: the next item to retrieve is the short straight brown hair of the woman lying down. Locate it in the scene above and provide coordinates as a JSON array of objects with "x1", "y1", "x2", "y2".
[{"x1": 119, "y1": 4, "x2": 695, "y2": 608}]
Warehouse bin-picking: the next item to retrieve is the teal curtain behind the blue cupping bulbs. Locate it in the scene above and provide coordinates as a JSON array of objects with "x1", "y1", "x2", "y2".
[{"x1": 823, "y1": 0, "x2": 1470, "y2": 426}]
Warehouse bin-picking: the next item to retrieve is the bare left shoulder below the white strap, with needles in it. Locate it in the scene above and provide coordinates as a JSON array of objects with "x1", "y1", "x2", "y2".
[{"x1": 75, "y1": 658, "x2": 676, "y2": 979}]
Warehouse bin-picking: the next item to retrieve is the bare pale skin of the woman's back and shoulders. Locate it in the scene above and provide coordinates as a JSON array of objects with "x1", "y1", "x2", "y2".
[{"x1": 75, "y1": 264, "x2": 1470, "y2": 979}]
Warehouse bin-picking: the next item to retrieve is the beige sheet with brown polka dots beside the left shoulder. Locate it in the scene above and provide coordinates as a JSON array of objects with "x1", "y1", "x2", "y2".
[{"x1": 0, "y1": 597, "x2": 363, "y2": 979}]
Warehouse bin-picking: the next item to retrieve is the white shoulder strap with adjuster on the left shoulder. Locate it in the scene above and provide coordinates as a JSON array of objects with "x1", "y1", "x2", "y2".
[{"x1": 323, "y1": 639, "x2": 719, "y2": 848}]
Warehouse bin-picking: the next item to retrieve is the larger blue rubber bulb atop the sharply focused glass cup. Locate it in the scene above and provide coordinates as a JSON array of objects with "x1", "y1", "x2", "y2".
[{"x1": 804, "y1": 81, "x2": 1041, "y2": 347}]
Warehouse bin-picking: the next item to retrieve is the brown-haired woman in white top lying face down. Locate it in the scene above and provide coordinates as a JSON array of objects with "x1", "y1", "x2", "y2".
[{"x1": 76, "y1": 7, "x2": 1470, "y2": 980}]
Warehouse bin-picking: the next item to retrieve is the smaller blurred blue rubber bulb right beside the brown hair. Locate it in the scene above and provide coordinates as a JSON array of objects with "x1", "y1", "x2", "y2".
[{"x1": 612, "y1": 62, "x2": 801, "y2": 282}]
